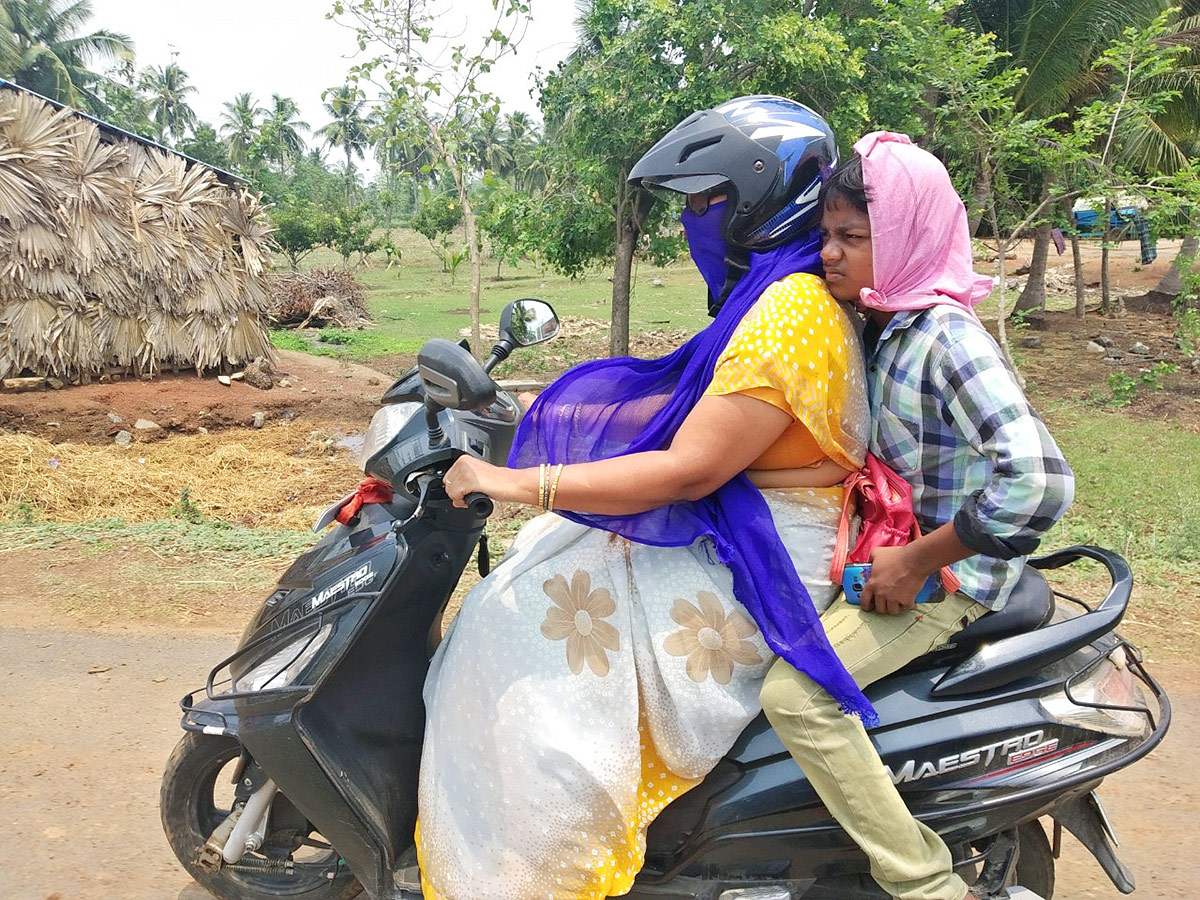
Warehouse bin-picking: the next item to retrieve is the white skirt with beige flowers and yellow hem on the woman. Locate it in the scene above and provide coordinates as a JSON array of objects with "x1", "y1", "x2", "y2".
[{"x1": 418, "y1": 494, "x2": 841, "y2": 900}]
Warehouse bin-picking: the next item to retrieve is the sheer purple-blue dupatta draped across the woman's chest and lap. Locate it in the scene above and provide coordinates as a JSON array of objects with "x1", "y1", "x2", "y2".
[{"x1": 509, "y1": 229, "x2": 878, "y2": 727}]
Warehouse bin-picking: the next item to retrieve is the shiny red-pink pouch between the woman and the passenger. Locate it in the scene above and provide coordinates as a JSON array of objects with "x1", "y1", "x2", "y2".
[{"x1": 829, "y1": 454, "x2": 961, "y2": 593}]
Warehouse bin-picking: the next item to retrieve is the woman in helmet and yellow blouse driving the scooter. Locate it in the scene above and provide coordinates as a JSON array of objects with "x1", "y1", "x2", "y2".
[{"x1": 418, "y1": 96, "x2": 874, "y2": 900}]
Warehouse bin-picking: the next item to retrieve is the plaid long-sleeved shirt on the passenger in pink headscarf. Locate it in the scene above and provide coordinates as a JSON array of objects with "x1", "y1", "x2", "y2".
[{"x1": 865, "y1": 304, "x2": 1075, "y2": 610}]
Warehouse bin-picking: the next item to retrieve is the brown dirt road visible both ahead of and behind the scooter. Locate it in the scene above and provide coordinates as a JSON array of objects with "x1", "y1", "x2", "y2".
[{"x1": 0, "y1": 626, "x2": 1200, "y2": 900}]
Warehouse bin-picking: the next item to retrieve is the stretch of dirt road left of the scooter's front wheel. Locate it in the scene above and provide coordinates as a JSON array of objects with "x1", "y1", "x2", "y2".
[{"x1": 0, "y1": 628, "x2": 235, "y2": 900}]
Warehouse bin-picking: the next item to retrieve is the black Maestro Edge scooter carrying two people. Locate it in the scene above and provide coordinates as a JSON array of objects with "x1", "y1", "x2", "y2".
[{"x1": 161, "y1": 300, "x2": 1171, "y2": 900}]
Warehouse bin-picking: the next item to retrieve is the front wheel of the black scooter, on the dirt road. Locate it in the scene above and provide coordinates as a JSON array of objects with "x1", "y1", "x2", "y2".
[{"x1": 161, "y1": 731, "x2": 362, "y2": 900}]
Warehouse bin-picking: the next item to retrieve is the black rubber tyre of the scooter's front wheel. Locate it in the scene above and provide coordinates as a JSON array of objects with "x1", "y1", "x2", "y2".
[{"x1": 160, "y1": 732, "x2": 362, "y2": 900}]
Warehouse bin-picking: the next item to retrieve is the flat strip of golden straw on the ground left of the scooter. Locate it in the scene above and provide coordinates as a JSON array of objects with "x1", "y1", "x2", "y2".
[{"x1": 0, "y1": 426, "x2": 362, "y2": 528}]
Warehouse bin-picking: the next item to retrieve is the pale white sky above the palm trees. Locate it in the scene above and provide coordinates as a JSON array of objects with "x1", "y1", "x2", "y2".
[{"x1": 88, "y1": 0, "x2": 576, "y2": 174}]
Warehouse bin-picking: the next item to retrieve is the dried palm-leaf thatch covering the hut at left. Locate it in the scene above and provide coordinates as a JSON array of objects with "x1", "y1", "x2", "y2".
[{"x1": 0, "y1": 89, "x2": 272, "y2": 379}]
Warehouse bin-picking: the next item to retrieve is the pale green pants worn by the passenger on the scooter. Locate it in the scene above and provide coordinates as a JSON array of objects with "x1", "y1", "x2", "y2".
[{"x1": 761, "y1": 594, "x2": 988, "y2": 900}]
